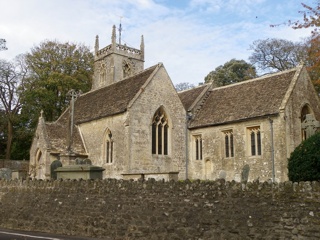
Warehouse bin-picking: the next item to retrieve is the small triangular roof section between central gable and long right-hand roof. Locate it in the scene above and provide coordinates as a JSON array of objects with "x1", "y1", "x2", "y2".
[{"x1": 178, "y1": 84, "x2": 209, "y2": 111}]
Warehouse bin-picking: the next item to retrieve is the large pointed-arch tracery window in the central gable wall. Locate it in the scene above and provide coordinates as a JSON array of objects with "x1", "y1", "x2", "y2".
[{"x1": 152, "y1": 108, "x2": 169, "y2": 155}]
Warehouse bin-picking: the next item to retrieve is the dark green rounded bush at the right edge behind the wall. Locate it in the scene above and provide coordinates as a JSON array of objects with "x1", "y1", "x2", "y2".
[{"x1": 288, "y1": 132, "x2": 320, "y2": 182}]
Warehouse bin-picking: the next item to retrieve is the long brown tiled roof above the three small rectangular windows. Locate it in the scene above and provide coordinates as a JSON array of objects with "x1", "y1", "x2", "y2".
[{"x1": 189, "y1": 67, "x2": 301, "y2": 128}]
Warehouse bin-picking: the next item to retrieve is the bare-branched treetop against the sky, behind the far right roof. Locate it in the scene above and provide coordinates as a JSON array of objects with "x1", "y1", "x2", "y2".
[{"x1": 249, "y1": 38, "x2": 306, "y2": 71}]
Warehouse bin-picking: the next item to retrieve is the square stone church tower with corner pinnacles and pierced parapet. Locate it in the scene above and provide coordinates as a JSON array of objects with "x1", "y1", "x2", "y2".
[{"x1": 92, "y1": 25, "x2": 144, "y2": 90}]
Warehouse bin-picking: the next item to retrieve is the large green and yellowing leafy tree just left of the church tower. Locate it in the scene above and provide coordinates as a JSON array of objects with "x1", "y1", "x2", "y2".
[{"x1": 22, "y1": 41, "x2": 93, "y2": 127}]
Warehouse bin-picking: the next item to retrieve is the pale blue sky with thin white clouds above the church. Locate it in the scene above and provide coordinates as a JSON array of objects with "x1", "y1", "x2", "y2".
[{"x1": 0, "y1": 0, "x2": 316, "y2": 86}]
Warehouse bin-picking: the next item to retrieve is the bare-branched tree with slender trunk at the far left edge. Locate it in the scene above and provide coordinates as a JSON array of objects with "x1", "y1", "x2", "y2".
[{"x1": 0, "y1": 55, "x2": 27, "y2": 159}]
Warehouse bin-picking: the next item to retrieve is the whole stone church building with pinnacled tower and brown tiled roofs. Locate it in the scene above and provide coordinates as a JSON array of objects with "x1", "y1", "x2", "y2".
[{"x1": 30, "y1": 27, "x2": 320, "y2": 182}]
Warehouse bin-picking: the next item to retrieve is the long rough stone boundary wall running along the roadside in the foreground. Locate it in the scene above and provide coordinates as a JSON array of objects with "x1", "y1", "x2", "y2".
[{"x1": 0, "y1": 179, "x2": 320, "y2": 239}]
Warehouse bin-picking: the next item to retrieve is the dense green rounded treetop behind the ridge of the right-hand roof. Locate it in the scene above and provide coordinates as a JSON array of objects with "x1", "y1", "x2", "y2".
[{"x1": 204, "y1": 59, "x2": 257, "y2": 87}]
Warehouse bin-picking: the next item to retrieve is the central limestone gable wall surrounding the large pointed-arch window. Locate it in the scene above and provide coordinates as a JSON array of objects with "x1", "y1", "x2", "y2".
[{"x1": 128, "y1": 66, "x2": 186, "y2": 179}]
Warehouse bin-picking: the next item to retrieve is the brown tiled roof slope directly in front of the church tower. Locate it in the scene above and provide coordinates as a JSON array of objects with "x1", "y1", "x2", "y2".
[{"x1": 74, "y1": 65, "x2": 158, "y2": 124}]
